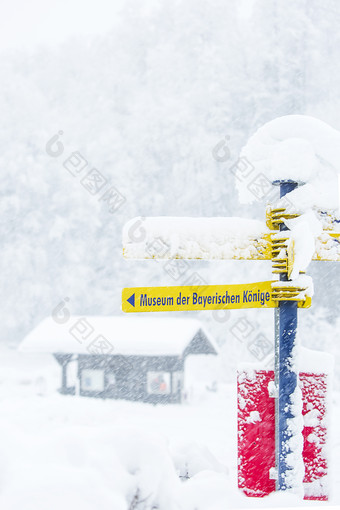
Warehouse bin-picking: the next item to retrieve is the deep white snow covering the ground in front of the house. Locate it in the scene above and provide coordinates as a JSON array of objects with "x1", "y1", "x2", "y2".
[{"x1": 0, "y1": 348, "x2": 340, "y2": 510}]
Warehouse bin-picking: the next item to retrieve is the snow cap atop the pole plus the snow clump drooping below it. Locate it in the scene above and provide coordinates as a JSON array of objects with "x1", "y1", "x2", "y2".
[{"x1": 236, "y1": 115, "x2": 340, "y2": 279}]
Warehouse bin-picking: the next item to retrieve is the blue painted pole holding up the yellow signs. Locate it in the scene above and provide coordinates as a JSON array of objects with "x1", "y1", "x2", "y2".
[{"x1": 275, "y1": 181, "x2": 298, "y2": 490}]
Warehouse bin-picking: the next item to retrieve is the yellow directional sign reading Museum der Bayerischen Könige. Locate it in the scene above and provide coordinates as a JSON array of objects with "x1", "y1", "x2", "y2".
[{"x1": 122, "y1": 281, "x2": 310, "y2": 313}]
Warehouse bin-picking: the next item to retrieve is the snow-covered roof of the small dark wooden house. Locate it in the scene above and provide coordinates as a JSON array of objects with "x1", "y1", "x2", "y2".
[{"x1": 19, "y1": 316, "x2": 218, "y2": 356}]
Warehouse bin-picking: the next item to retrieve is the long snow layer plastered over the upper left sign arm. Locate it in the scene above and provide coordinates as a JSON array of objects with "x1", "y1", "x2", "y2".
[{"x1": 123, "y1": 217, "x2": 268, "y2": 260}]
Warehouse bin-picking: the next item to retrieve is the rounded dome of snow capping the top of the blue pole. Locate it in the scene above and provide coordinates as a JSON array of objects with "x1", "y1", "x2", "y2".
[{"x1": 236, "y1": 115, "x2": 340, "y2": 209}]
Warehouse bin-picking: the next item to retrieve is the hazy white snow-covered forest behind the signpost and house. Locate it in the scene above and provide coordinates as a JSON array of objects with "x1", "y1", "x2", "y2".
[{"x1": 0, "y1": 0, "x2": 340, "y2": 378}]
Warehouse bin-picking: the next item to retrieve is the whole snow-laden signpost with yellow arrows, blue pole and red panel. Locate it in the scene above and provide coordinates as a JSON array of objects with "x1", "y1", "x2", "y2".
[{"x1": 122, "y1": 116, "x2": 340, "y2": 499}]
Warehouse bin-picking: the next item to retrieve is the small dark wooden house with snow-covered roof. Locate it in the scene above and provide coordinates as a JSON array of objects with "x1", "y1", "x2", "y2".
[{"x1": 20, "y1": 316, "x2": 217, "y2": 404}]
